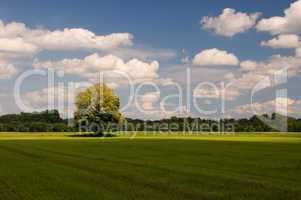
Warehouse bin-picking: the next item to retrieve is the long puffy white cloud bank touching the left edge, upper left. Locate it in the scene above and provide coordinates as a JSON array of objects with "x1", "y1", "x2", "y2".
[{"x1": 0, "y1": 20, "x2": 133, "y2": 55}]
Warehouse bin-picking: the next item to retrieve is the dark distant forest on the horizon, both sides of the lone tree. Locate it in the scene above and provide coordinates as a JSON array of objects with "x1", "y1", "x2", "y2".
[{"x1": 0, "y1": 110, "x2": 301, "y2": 132}]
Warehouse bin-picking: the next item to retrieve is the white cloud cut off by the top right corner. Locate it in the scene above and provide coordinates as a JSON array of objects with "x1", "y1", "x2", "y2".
[{"x1": 256, "y1": 0, "x2": 301, "y2": 34}]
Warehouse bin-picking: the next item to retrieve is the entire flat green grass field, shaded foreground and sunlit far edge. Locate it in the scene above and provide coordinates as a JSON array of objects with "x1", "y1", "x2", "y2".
[{"x1": 0, "y1": 133, "x2": 301, "y2": 200}]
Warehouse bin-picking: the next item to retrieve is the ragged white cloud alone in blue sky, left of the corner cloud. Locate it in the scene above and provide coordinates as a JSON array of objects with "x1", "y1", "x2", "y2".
[{"x1": 201, "y1": 8, "x2": 261, "y2": 37}]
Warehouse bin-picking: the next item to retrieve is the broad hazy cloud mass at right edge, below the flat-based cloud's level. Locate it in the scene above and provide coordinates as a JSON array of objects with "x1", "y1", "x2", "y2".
[{"x1": 207, "y1": 53, "x2": 301, "y2": 100}]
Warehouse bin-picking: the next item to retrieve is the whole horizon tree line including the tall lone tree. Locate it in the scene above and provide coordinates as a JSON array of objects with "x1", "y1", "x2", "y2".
[{"x1": 0, "y1": 83, "x2": 301, "y2": 136}]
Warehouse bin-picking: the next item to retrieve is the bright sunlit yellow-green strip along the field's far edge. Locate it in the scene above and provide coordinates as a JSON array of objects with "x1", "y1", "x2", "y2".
[{"x1": 0, "y1": 132, "x2": 301, "y2": 143}]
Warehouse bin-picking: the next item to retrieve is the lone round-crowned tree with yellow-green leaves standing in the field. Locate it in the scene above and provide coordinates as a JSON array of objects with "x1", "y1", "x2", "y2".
[{"x1": 74, "y1": 83, "x2": 122, "y2": 136}]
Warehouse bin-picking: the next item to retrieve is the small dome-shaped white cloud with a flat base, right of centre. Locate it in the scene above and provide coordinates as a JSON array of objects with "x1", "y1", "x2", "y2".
[{"x1": 193, "y1": 48, "x2": 239, "y2": 66}]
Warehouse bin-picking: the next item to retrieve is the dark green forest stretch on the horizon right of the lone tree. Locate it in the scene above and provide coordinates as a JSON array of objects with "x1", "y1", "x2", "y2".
[{"x1": 121, "y1": 113, "x2": 301, "y2": 132}]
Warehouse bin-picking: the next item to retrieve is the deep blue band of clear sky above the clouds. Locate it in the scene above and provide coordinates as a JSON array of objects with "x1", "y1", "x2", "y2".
[{"x1": 0, "y1": 0, "x2": 292, "y2": 59}]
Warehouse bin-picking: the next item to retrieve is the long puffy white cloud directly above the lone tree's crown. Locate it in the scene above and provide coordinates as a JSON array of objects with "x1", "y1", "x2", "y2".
[{"x1": 33, "y1": 53, "x2": 159, "y2": 82}]
